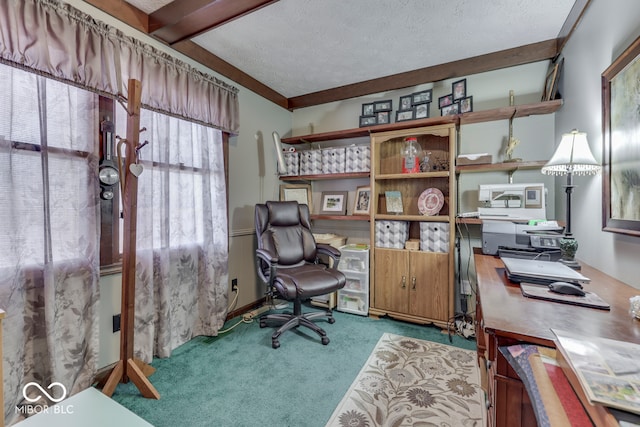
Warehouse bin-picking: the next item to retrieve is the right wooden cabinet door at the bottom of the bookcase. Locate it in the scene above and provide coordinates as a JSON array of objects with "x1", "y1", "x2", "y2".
[{"x1": 409, "y1": 251, "x2": 449, "y2": 322}]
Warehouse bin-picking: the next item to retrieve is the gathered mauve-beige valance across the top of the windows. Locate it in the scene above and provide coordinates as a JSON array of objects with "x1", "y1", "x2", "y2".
[{"x1": 0, "y1": 0, "x2": 240, "y2": 134}]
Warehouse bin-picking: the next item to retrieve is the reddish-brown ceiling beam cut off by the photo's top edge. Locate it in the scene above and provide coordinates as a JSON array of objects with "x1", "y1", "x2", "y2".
[{"x1": 149, "y1": 0, "x2": 278, "y2": 45}]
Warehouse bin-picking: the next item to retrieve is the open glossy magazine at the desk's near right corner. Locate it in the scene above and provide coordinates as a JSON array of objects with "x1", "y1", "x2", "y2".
[{"x1": 551, "y1": 329, "x2": 640, "y2": 414}]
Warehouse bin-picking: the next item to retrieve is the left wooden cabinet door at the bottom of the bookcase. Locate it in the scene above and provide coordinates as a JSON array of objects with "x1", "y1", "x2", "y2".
[{"x1": 373, "y1": 248, "x2": 409, "y2": 313}]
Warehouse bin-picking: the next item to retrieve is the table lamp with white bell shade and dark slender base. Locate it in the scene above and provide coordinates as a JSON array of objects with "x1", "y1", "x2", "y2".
[{"x1": 542, "y1": 129, "x2": 601, "y2": 270}]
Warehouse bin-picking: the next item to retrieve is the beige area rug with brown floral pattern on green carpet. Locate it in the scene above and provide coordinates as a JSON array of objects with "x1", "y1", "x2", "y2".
[{"x1": 327, "y1": 333, "x2": 484, "y2": 427}]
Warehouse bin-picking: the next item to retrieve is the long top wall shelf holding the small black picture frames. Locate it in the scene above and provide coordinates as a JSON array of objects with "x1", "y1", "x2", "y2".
[{"x1": 282, "y1": 99, "x2": 562, "y2": 145}]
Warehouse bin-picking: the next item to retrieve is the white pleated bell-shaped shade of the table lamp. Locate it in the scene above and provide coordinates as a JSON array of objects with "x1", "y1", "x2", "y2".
[{"x1": 542, "y1": 129, "x2": 601, "y2": 175}]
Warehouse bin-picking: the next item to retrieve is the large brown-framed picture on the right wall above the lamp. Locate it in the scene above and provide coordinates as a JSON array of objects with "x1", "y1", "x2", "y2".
[{"x1": 602, "y1": 37, "x2": 640, "y2": 236}]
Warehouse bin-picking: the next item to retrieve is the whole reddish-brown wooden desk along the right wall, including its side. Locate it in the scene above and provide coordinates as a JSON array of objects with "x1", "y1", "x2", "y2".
[{"x1": 474, "y1": 248, "x2": 640, "y2": 427}]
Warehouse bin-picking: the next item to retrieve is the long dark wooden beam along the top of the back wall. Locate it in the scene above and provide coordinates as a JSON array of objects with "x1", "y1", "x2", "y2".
[{"x1": 288, "y1": 39, "x2": 558, "y2": 110}]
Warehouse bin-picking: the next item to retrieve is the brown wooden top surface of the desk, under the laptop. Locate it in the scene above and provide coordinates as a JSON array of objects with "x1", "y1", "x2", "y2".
[{"x1": 474, "y1": 251, "x2": 640, "y2": 347}]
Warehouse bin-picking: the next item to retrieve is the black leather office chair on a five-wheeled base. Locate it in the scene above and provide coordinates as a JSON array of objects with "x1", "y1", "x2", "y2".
[{"x1": 255, "y1": 202, "x2": 345, "y2": 348}]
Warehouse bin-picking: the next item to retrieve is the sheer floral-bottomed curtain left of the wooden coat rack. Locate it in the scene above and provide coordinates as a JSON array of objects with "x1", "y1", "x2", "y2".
[{"x1": 0, "y1": 65, "x2": 99, "y2": 423}]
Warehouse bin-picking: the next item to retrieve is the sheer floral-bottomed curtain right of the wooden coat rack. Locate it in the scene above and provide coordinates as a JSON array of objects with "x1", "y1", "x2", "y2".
[{"x1": 116, "y1": 108, "x2": 228, "y2": 362}]
